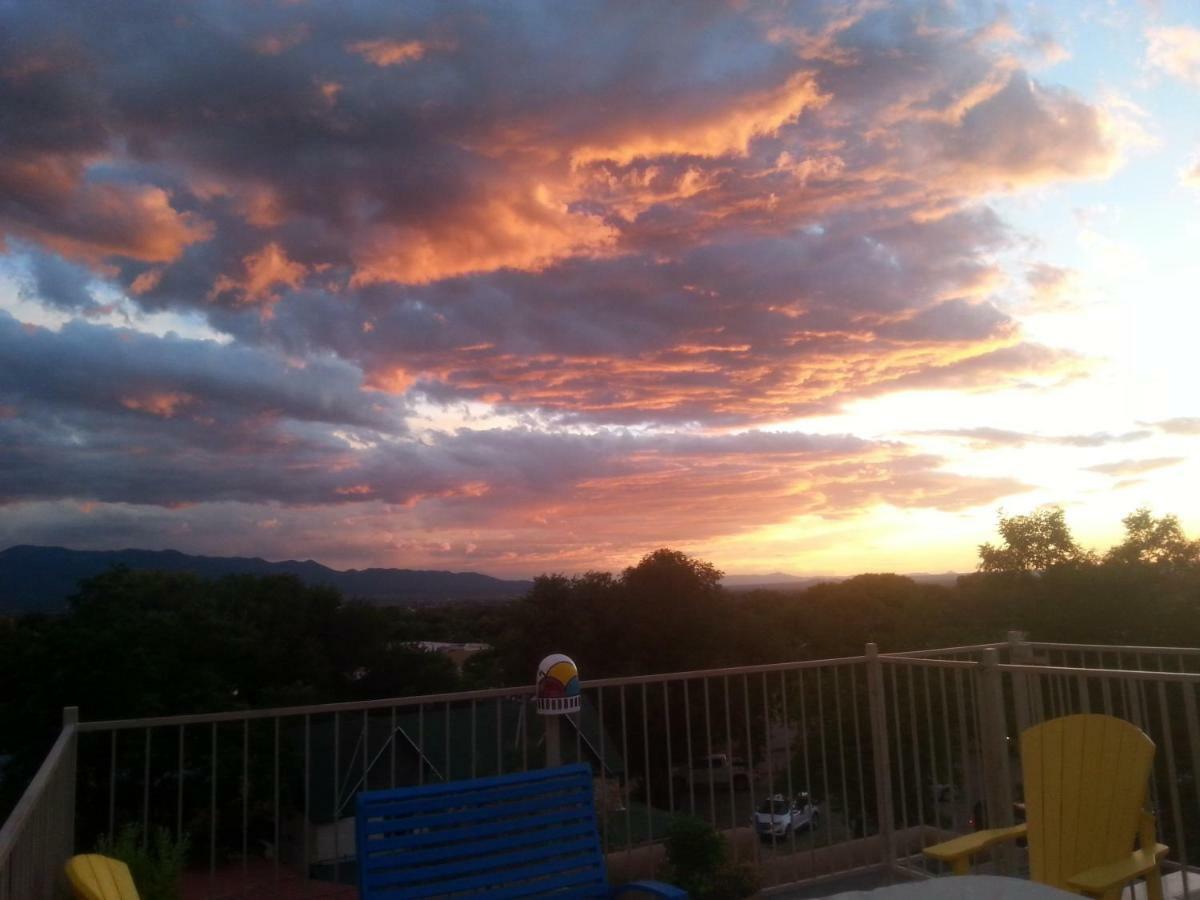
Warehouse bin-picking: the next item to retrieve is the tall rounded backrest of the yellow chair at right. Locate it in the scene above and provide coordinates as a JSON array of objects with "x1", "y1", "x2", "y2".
[{"x1": 1021, "y1": 714, "x2": 1154, "y2": 888}]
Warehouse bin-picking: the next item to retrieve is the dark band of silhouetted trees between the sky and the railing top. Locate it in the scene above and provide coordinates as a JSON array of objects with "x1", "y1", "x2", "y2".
[{"x1": 0, "y1": 508, "x2": 1200, "y2": 811}]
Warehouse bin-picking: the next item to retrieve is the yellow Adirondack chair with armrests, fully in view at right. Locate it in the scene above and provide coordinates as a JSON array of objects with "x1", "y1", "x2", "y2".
[{"x1": 925, "y1": 715, "x2": 1168, "y2": 900}]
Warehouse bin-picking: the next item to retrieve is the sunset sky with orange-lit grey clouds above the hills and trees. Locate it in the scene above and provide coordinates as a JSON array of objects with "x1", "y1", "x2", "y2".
[{"x1": 0, "y1": 0, "x2": 1200, "y2": 576}]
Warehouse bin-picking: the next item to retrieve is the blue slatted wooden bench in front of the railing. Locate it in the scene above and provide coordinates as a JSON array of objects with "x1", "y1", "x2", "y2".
[{"x1": 355, "y1": 763, "x2": 688, "y2": 900}]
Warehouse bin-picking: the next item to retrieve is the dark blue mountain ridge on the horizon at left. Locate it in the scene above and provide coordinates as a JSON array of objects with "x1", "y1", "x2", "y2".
[{"x1": 0, "y1": 546, "x2": 533, "y2": 612}]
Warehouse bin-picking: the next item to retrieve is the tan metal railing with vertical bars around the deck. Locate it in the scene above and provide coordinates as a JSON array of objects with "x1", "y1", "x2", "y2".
[{"x1": 7, "y1": 636, "x2": 1200, "y2": 900}]
